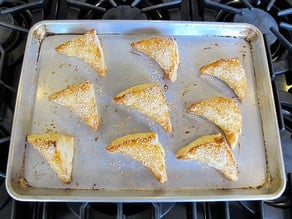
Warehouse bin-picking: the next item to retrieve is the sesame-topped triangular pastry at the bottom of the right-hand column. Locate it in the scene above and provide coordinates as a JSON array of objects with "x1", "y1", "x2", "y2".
[{"x1": 176, "y1": 134, "x2": 238, "y2": 181}]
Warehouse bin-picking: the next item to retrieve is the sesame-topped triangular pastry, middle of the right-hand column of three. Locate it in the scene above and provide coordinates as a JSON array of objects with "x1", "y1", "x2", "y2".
[{"x1": 187, "y1": 97, "x2": 242, "y2": 149}]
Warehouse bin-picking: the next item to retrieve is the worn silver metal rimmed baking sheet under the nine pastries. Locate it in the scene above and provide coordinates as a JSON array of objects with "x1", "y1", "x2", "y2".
[{"x1": 7, "y1": 21, "x2": 285, "y2": 201}]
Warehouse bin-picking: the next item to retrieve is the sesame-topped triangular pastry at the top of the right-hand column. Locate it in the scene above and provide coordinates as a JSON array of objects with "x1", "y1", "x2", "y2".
[{"x1": 200, "y1": 57, "x2": 247, "y2": 101}]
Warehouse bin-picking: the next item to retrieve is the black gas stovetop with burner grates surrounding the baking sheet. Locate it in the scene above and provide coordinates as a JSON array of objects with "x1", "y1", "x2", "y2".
[{"x1": 0, "y1": 0, "x2": 292, "y2": 219}]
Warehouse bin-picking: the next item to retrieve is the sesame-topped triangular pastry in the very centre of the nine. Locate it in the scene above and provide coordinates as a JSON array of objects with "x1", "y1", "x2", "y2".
[{"x1": 113, "y1": 82, "x2": 173, "y2": 133}]
